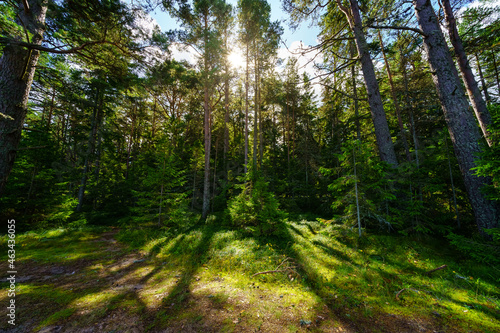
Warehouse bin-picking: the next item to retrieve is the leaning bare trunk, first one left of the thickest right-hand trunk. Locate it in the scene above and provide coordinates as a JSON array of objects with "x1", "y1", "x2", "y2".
[{"x1": 337, "y1": 0, "x2": 398, "y2": 166}]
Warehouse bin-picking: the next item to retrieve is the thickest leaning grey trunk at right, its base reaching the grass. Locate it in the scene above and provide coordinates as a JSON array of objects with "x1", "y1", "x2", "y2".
[{"x1": 413, "y1": 0, "x2": 498, "y2": 232}]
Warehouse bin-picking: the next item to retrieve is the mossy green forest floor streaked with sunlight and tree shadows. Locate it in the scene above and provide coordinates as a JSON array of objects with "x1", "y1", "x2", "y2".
[{"x1": 0, "y1": 220, "x2": 500, "y2": 333}]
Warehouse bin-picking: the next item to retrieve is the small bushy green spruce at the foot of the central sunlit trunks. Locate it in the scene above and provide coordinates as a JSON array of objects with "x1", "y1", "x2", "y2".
[{"x1": 228, "y1": 170, "x2": 286, "y2": 236}]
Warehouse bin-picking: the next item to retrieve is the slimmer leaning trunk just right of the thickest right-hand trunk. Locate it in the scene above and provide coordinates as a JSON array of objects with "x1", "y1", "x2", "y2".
[{"x1": 443, "y1": 0, "x2": 492, "y2": 146}]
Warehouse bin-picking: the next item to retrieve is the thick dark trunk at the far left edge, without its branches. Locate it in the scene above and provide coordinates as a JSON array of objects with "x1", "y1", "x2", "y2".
[{"x1": 0, "y1": 0, "x2": 47, "y2": 196}]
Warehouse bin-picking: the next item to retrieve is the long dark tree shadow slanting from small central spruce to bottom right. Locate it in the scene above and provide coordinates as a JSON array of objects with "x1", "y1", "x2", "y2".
[{"x1": 252, "y1": 223, "x2": 466, "y2": 332}]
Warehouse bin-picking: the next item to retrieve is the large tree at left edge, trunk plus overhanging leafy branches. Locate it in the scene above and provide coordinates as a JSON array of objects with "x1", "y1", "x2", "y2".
[{"x1": 0, "y1": 0, "x2": 148, "y2": 195}]
